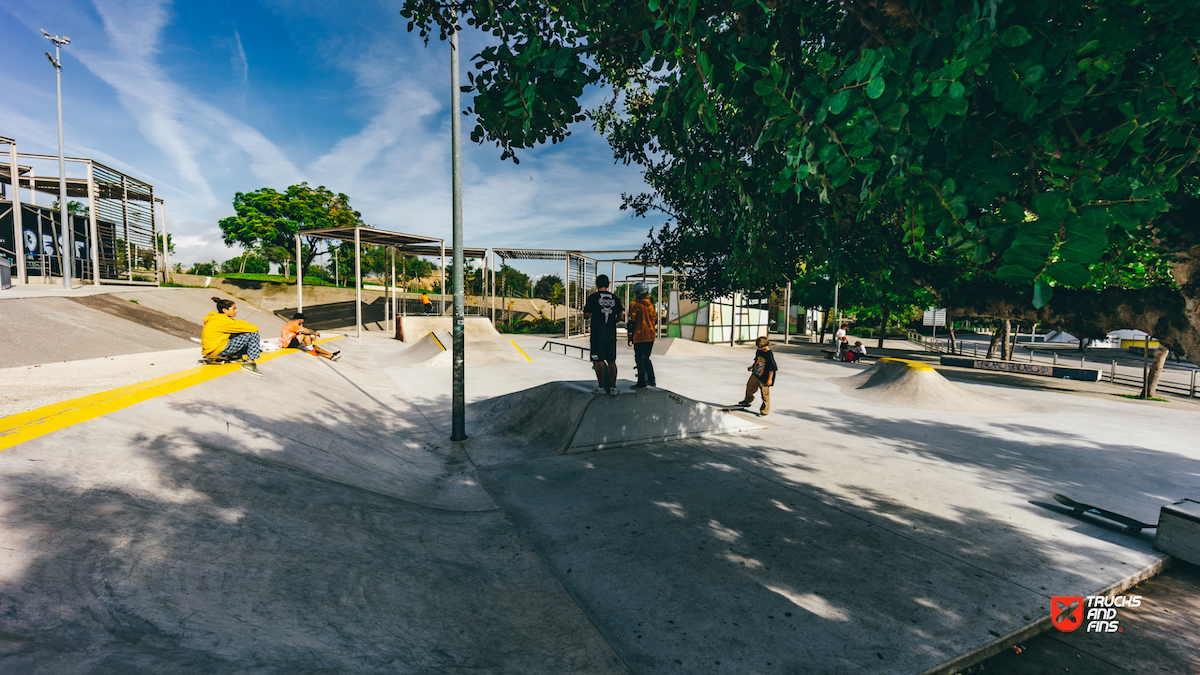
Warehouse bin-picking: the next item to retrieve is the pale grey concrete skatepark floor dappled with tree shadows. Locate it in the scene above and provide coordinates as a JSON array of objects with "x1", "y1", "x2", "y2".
[{"x1": 0, "y1": 324, "x2": 1200, "y2": 674}]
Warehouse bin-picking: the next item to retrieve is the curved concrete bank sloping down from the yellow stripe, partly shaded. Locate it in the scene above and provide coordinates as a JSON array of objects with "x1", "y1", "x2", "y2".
[{"x1": 0, "y1": 389, "x2": 624, "y2": 674}]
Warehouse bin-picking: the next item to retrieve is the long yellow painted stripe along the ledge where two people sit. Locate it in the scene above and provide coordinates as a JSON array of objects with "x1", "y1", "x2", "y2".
[{"x1": 0, "y1": 335, "x2": 342, "y2": 450}]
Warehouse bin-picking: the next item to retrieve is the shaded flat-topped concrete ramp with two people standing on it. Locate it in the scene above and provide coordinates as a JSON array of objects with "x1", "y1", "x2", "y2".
[{"x1": 467, "y1": 382, "x2": 764, "y2": 466}]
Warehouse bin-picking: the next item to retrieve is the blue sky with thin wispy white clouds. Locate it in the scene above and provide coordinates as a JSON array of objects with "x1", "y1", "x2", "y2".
[{"x1": 0, "y1": 0, "x2": 658, "y2": 271}]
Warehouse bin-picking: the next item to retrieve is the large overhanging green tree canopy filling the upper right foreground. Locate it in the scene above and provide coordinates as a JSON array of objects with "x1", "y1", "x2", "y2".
[{"x1": 402, "y1": 0, "x2": 1200, "y2": 358}]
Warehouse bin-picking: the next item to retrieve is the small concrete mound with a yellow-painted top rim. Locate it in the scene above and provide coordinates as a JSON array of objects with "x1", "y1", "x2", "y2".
[{"x1": 839, "y1": 358, "x2": 1024, "y2": 413}]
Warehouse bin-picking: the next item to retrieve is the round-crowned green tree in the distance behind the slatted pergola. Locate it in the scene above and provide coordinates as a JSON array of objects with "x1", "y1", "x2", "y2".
[{"x1": 218, "y1": 183, "x2": 366, "y2": 277}]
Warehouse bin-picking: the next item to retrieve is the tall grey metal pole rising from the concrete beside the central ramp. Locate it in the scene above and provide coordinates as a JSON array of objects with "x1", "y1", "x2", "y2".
[{"x1": 451, "y1": 19, "x2": 467, "y2": 441}]
